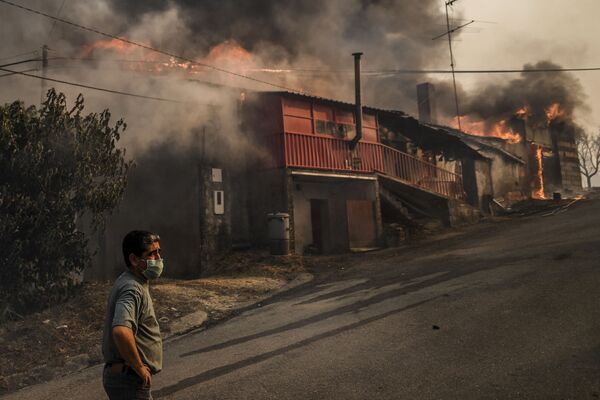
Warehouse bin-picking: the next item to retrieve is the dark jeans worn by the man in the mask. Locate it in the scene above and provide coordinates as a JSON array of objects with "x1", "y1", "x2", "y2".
[{"x1": 102, "y1": 366, "x2": 152, "y2": 400}]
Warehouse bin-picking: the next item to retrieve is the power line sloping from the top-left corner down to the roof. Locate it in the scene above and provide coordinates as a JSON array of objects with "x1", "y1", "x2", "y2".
[{"x1": 0, "y1": 0, "x2": 305, "y2": 94}]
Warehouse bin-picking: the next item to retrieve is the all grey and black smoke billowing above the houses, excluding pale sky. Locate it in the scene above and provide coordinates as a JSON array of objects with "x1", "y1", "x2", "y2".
[{"x1": 0, "y1": 0, "x2": 585, "y2": 145}]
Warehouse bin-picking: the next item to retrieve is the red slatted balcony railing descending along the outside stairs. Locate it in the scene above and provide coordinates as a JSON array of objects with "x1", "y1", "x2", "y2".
[{"x1": 270, "y1": 133, "x2": 464, "y2": 199}]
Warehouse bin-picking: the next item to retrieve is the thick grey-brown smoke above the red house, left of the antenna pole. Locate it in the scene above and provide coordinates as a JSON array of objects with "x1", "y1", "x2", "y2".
[{"x1": 0, "y1": 0, "x2": 445, "y2": 153}]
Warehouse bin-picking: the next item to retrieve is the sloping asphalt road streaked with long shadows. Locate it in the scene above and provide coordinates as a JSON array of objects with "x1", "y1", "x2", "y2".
[{"x1": 8, "y1": 200, "x2": 600, "y2": 399}]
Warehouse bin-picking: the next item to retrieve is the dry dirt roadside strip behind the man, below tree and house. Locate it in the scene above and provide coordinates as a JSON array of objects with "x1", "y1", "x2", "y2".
[{"x1": 0, "y1": 252, "x2": 306, "y2": 396}]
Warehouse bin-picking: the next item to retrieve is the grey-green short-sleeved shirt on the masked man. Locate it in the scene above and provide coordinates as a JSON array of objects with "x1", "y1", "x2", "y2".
[{"x1": 102, "y1": 271, "x2": 162, "y2": 373}]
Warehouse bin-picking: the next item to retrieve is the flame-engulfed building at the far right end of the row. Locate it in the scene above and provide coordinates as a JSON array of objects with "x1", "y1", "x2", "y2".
[{"x1": 413, "y1": 77, "x2": 581, "y2": 211}]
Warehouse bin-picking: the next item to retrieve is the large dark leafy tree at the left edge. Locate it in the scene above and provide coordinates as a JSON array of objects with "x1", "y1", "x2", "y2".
[{"x1": 0, "y1": 89, "x2": 131, "y2": 316}]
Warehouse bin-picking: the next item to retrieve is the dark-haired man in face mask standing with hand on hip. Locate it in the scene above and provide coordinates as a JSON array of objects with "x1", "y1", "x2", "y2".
[{"x1": 102, "y1": 231, "x2": 163, "y2": 400}]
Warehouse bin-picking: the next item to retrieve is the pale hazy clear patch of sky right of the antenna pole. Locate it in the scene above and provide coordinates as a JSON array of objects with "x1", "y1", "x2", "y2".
[{"x1": 441, "y1": 0, "x2": 600, "y2": 131}]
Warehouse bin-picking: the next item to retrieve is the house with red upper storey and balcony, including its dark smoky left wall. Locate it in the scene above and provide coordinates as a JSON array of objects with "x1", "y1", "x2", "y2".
[{"x1": 89, "y1": 84, "x2": 482, "y2": 277}]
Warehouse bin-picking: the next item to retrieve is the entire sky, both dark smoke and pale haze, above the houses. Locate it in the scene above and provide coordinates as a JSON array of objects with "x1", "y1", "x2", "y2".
[{"x1": 0, "y1": 0, "x2": 600, "y2": 161}]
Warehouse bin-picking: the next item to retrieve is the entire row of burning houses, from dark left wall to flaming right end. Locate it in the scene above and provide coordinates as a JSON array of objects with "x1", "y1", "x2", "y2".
[{"x1": 82, "y1": 76, "x2": 577, "y2": 282}]
